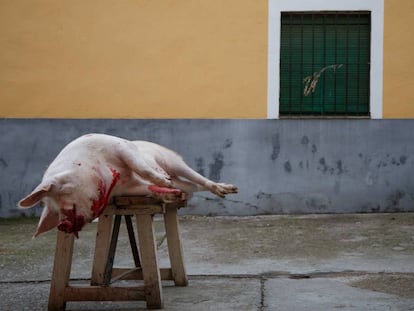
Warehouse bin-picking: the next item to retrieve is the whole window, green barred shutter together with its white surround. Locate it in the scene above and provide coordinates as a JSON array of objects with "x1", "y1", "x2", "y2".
[{"x1": 267, "y1": 0, "x2": 384, "y2": 119}]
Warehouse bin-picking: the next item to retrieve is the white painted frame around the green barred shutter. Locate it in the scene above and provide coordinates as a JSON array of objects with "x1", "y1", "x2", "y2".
[{"x1": 267, "y1": 0, "x2": 384, "y2": 119}]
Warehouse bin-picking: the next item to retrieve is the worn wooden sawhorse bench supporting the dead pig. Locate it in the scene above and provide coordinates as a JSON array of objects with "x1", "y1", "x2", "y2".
[{"x1": 49, "y1": 196, "x2": 188, "y2": 311}]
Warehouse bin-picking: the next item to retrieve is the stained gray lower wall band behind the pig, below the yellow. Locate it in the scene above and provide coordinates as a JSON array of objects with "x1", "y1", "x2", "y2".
[{"x1": 0, "y1": 119, "x2": 414, "y2": 217}]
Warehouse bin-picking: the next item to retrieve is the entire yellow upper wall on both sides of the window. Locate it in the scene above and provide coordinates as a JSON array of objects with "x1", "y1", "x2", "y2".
[{"x1": 0, "y1": 0, "x2": 414, "y2": 118}]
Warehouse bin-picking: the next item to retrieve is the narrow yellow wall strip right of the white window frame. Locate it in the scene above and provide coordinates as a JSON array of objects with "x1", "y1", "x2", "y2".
[{"x1": 383, "y1": 0, "x2": 414, "y2": 118}]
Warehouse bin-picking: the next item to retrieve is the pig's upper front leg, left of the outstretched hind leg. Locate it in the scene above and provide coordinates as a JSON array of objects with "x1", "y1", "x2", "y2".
[{"x1": 119, "y1": 144, "x2": 172, "y2": 188}]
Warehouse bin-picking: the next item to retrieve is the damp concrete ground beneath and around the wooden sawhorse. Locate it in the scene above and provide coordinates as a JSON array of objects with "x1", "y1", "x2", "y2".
[{"x1": 0, "y1": 213, "x2": 414, "y2": 311}]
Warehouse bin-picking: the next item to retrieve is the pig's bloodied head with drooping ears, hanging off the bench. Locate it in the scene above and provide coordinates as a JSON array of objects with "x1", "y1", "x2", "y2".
[{"x1": 18, "y1": 168, "x2": 119, "y2": 237}]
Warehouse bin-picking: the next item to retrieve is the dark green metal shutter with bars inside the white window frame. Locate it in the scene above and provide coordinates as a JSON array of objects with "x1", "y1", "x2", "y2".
[{"x1": 279, "y1": 12, "x2": 371, "y2": 116}]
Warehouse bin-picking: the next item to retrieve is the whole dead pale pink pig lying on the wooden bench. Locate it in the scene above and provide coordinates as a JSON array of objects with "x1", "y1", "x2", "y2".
[{"x1": 19, "y1": 134, "x2": 237, "y2": 237}]
